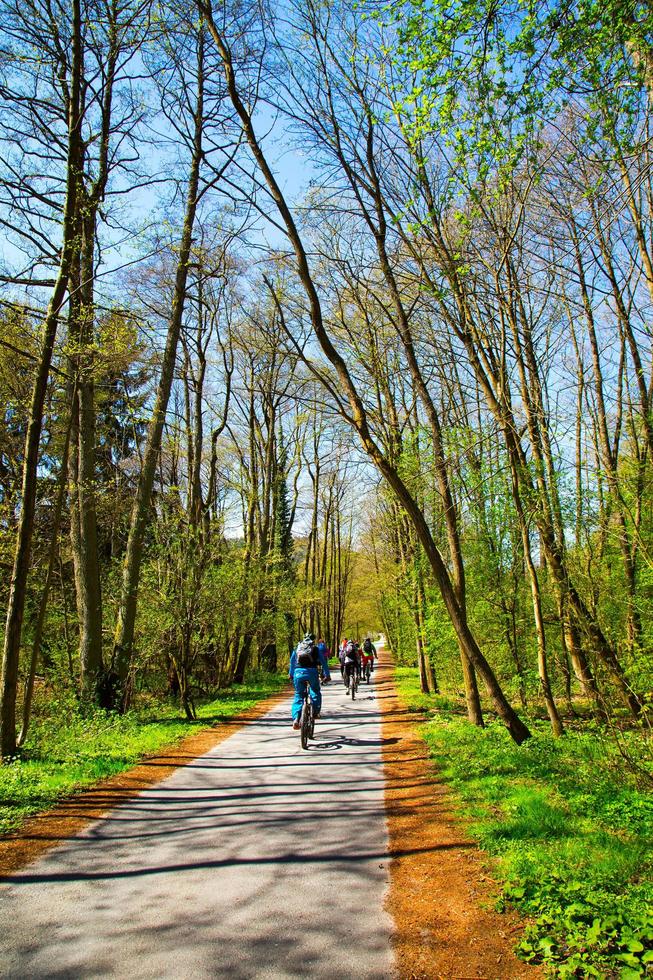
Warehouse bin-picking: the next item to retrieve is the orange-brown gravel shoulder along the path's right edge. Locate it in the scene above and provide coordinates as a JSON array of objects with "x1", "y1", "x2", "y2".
[{"x1": 376, "y1": 653, "x2": 544, "y2": 980}]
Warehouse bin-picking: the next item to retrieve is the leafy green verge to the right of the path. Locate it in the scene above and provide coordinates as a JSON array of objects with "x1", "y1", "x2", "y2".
[{"x1": 397, "y1": 668, "x2": 653, "y2": 980}]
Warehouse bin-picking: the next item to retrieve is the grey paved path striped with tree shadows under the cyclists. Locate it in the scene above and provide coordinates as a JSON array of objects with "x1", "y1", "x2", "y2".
[{"x1": 0, "y1": 675, "x2": 393, "y2": 980}]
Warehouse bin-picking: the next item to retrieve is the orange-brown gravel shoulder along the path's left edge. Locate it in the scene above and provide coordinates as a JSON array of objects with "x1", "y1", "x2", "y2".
[{"x1": 0, "y1": 691, "x2": 288, "y2": 879}]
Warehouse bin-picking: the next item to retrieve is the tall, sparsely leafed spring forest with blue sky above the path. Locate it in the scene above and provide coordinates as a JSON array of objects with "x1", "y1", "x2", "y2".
[{"x1": 0, "y1": 0, "x2": 653, "y2": 975}]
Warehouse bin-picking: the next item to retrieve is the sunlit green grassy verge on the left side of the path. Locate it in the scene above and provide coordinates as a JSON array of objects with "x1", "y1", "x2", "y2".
[{"x1": 0, "y1": 674, "x2": 286, "y2": 833}]
